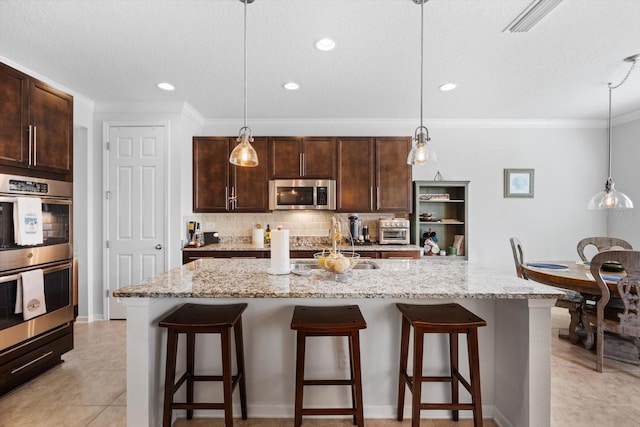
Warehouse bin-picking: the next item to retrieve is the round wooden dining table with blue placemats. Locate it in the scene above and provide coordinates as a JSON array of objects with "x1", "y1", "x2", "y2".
[{"x1": 522, "y1": 261, "x2": 624, "y2": 357}]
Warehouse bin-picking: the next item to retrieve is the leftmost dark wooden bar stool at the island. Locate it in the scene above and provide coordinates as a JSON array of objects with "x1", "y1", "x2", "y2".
[{"x1": 158, "y1": 304, "x2": 247, "y2": 427}]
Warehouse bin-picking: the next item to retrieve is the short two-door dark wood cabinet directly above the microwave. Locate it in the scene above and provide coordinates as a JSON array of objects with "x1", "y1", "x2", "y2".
[{"x1": 269, "y1": 137, "x2": 336, "y2": 179}]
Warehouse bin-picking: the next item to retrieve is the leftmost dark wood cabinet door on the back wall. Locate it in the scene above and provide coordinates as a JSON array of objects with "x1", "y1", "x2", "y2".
[{"x1": 193, "y1": 137, "x2": 231, "y2": 212}]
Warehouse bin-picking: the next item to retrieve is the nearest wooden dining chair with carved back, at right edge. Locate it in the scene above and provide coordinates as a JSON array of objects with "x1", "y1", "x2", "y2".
[{"x1": 584, "y1": 250, "x2": 640, "y2": 372}]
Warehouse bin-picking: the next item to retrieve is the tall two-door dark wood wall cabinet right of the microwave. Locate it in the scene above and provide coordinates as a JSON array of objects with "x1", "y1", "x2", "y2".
[{"x1": 336, "y1": 137, "x2": 412, "y2": 213}]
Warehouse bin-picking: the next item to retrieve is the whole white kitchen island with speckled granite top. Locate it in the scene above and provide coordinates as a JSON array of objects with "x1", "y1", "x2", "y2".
[{"x1": 114, "y1": 257, "x2": 560, "y2": 427}]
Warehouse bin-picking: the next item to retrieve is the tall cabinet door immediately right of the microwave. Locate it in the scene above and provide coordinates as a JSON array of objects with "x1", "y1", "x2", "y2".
[{"x1": 336, "y1": 138, "x2": 374, "y2": 212}]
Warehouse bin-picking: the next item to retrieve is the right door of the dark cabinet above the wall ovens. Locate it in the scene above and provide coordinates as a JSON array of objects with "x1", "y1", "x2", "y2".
[{"x1": 29, "y1": 79, "x2": 73, "y2": 175}]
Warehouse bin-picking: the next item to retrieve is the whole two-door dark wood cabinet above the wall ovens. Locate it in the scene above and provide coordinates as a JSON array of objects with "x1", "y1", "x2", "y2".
[{"x1": 0, "y1": 63, "x2": 73, "y2": 181}]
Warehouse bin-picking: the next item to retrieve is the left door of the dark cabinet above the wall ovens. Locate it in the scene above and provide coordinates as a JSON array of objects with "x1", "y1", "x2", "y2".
[{"x1": 0, "y1": 63, "x2": 29, "y2": 167}]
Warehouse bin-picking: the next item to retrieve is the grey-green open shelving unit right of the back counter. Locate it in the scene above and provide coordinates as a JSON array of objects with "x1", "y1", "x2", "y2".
[{"x1": 411, "y1": 181, "x2": 469, "y2": 259}]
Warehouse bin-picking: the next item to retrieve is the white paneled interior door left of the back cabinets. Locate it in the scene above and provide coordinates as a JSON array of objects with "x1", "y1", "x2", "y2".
[{"x1": 106, "y1": 126, "x2": 166, "y2": 319}]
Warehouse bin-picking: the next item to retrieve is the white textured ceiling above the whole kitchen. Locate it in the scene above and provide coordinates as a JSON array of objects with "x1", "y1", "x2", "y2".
[{"x1": 0, "y1": 0, "x2": 640, "y2": 119}]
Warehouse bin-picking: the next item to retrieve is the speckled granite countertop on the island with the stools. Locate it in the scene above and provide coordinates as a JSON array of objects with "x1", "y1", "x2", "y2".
[{"x1": 113, "y1": 257, "x2": 563, "y2": 299}]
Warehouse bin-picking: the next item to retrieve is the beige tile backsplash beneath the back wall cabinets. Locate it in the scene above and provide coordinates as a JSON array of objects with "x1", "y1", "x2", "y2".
[{"x1": 183, "y1": 211, "x2": 402, "y2": 243}]
